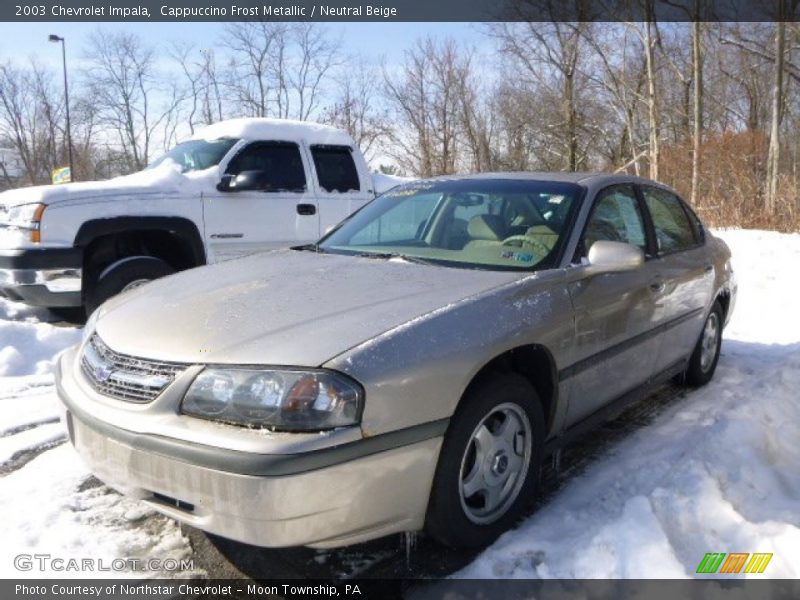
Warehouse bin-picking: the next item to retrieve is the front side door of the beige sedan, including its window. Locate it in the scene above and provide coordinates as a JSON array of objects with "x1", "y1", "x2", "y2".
[{"x1": 562, "y1": 184, "x2": 664, "y2": 426}]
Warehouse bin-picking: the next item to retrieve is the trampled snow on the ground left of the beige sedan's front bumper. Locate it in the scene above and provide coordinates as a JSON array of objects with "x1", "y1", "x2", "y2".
[{"x1": 0, "y1": 299, "x2": 198, "y2": 578}]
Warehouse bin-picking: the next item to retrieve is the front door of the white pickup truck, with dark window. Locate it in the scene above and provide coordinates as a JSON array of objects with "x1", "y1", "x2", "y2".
[{"x1": 203, "y1": 141, "x2": 319, "y2": 262}]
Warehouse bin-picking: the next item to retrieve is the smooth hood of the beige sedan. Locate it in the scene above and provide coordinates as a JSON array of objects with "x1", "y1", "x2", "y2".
[{"x1": 96, "y1": 250, "x2": 522, "y2": 366}]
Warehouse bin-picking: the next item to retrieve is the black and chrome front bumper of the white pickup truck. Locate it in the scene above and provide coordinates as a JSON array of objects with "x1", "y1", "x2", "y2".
[{"x1": 0, "y1": 248, "x2": 83, "y2": 307}]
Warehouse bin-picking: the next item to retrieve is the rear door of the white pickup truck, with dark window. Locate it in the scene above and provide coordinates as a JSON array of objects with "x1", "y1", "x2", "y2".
[{"x1": 309, "y1": 144, "x2": 374, "y2": 236}]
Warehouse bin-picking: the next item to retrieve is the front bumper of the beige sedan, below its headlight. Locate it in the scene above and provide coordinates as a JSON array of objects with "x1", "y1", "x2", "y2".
[{"x1": 56, "y1": 350, "x2": 446, "y2": 548}]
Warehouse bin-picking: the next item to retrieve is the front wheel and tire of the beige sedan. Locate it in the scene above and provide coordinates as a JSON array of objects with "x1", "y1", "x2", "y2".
[{"x1": 425, "y1": 374, "x2": 545, "y2": 548}]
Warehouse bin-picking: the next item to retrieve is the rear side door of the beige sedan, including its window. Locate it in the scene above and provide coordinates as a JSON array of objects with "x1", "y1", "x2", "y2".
[{"x1": 640, "y1": 185, "x2": 714, "y2": 371}]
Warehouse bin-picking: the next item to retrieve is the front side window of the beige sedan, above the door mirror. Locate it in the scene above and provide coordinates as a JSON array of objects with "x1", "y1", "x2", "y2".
[{"x1": 580, "y1": 185, "x2": 647, "y2": 257}]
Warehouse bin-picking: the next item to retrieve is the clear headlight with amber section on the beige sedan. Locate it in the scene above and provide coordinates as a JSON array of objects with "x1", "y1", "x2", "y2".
[{"x1": 181, "y1": 368, "x2": 364, "y2": 431}]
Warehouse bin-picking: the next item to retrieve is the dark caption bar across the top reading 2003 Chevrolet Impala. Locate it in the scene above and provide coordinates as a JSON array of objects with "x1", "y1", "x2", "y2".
[{"x1": 0, "y1": 0, "x2": 800, "y2": 23}]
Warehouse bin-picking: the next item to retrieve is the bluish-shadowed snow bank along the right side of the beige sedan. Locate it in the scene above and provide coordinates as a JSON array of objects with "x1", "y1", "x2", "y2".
[{"x1": 458, "y1": 231, "x2": 800, "y2": 578}]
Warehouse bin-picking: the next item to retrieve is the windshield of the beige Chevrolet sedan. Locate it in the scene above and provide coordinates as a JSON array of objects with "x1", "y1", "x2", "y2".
[{"x1": 315, "y1": 179, "x2": 582, "y2": 270}]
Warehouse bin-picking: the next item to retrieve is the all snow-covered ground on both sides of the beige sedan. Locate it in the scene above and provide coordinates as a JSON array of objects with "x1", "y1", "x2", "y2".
[{"x1": 0, "y1": 231, "x2": 800, "y2": 578}]
